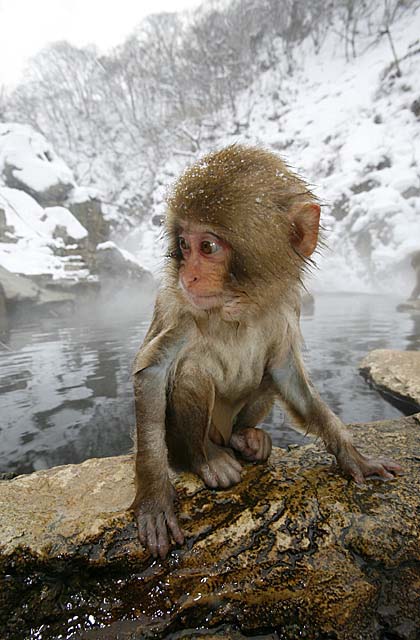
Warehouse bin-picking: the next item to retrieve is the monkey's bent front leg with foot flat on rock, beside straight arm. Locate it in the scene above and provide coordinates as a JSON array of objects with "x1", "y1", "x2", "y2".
[{"x1": 167, "y1": 370, "x2": 242, "y2": 489}]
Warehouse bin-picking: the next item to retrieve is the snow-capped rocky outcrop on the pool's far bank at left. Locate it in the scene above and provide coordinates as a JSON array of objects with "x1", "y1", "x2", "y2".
[{"x1": 0, "y1": 123, "x2": 148, "y2": 285}]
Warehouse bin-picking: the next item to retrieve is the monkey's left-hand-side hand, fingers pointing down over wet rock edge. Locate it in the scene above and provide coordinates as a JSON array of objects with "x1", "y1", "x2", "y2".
[{"x1": 131, "y1": 488, "x2": 184, "y2": 559}]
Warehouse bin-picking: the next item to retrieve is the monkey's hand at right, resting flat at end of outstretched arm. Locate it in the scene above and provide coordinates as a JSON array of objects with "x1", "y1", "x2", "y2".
[{"x1": 335, "y1": 442, "x2": 403, "y2": 484}]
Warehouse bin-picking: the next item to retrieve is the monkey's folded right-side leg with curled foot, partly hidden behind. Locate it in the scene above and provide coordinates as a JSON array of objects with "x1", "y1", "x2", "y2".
[{"x1": 229, "y1": 388, "x2": 276, "y2": 462}]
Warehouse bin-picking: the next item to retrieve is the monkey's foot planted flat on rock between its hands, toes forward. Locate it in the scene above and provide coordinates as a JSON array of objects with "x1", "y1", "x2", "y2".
[{"x1": 194, "y1": 441, "x2": 242, "y2": 489}]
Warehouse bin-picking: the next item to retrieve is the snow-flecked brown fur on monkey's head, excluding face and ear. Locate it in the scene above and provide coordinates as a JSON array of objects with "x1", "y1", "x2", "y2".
[{"x1": 165, "y1": 145, "x2": 317, "y2": 294}]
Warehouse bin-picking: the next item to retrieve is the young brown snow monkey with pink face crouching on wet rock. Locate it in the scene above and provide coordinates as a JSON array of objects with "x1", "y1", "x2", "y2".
[{"x1": 131, "y1": 145, "x2": 401, "y2": 558}]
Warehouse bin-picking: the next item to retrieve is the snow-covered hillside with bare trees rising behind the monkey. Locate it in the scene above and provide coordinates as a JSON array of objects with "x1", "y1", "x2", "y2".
[{"x1": 4, "y1": 5, "x2": 420, "y2": 296}]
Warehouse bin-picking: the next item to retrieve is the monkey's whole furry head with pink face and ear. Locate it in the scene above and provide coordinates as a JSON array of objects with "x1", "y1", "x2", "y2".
[{"x1": 165, "y1": 145, "x2": 320, "y2": 321}]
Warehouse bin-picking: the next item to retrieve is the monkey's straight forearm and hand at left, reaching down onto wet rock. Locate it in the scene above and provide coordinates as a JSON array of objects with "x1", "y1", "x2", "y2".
[{"x1": 131, "y1": 365, "x2": 184, "y2": 558}]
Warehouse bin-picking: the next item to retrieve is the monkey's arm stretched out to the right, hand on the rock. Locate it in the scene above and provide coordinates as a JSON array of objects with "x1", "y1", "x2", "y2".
[{"x1": 271, "y1": 349, "x2": 402, "y2": 484}]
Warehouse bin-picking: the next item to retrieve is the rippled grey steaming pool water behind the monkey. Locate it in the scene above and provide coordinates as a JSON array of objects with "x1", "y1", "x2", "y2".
[{"x1": 0, "y1": 295, "x2": 420, "y2": 473}]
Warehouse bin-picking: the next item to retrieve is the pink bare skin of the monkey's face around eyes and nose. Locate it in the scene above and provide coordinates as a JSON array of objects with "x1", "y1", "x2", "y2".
[{"x1": 178, "y1": 224, "x2": 231, "y2": 310}]
